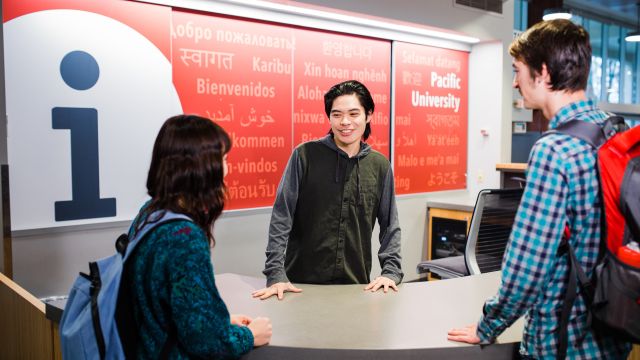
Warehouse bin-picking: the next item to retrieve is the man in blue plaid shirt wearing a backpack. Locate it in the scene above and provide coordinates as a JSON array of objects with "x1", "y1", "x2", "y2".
[{"x1": 448, "y1": 20, "x2": 630, "y2": 359}]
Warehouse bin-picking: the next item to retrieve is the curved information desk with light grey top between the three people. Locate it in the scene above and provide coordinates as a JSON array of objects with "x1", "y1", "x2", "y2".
[{"x1": 47, "y1": 272, "x2": 523, "y2": 360}]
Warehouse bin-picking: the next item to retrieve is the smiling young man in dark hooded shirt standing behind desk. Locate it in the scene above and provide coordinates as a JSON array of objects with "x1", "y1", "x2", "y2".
[{"x1": 253, "y1": 80, "x2": 402, "y2": 299}]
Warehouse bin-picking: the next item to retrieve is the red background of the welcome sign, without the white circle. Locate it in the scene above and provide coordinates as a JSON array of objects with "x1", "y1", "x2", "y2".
[{"x1": 8, "y1": 0, "x2": 468, "y2": 209}]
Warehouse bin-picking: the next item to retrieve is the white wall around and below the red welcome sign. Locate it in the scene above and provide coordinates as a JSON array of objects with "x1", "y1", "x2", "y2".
[{"x1": 1, "y1": 0, "x2": 513, "y2": 297}]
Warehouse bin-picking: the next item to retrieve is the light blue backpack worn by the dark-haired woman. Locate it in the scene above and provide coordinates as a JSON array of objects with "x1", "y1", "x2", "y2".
[{"x1": 60, "y1": 211, "x2": 192, "y2": 359}]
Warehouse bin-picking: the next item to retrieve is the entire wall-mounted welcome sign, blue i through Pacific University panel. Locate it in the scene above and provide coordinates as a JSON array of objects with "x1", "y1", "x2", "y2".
[{"x1": 3, "y1": 0, "x2": 467, "y2": 230}]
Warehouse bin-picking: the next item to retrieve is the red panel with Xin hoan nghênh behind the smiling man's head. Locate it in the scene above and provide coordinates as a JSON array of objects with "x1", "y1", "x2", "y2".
[{"x1": 293, "y1": 29, "x2": 391, "y2": 158}]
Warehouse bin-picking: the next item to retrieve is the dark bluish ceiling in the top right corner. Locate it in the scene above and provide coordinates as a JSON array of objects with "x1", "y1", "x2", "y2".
[{"x1": 564, "y1": 0, "x2": 639, "y2": 27}]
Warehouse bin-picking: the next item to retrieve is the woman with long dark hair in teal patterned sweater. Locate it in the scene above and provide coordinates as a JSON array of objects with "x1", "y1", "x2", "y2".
[{"x1": 124, "y1": 115, "x2": 271, "y2": 359}]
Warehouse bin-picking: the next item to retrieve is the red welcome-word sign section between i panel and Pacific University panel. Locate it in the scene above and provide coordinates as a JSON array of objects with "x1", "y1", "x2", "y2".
[{"x1": 171, "y1": 10, "x2": 391, "y2": 209}]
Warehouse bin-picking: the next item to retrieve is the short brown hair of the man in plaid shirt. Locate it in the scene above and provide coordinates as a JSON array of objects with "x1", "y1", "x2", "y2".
[{"x1": 509, "y1": 19, "x2": 591, "y2": 92}]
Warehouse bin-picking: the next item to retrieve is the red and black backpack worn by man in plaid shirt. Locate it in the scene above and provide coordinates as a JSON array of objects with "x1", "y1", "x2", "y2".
[{"x1": 547, "y1": 116, "x2": 640, "y2": 359}]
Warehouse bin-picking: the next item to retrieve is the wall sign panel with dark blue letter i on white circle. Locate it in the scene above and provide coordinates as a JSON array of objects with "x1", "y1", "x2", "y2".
[{"x1": 3, "y1": 0, "x2": 182, "y2": 230}]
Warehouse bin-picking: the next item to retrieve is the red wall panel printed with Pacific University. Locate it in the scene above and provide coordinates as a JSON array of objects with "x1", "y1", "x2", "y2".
[{"x1": 394, "y1": 42, "x2": 469, "y2": 194}]
